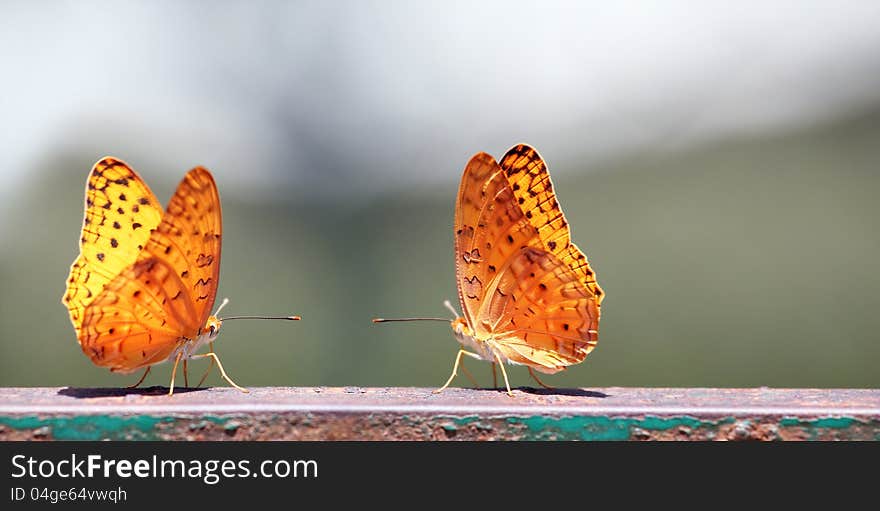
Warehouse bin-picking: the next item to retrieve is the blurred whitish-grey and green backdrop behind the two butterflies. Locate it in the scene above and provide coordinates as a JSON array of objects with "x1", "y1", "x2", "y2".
[{"x1": 0, "y1": 2, "x2": 880, "y2": 387}]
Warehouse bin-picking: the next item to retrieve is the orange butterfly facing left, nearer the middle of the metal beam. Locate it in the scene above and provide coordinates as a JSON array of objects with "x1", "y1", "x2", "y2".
[{"x1": 374, "y1": 145, "x2": 604, "y2": 395}]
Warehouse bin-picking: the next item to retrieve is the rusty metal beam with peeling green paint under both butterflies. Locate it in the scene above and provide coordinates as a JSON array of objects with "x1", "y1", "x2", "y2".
[{"x1": 0, "y1": 387, "x2": 880, "y2": 440}]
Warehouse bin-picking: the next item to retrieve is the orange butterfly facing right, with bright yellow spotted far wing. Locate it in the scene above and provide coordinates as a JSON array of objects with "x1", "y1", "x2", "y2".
[{"x1": 62, "y1": 157, "x2": 299, "y2": 395}]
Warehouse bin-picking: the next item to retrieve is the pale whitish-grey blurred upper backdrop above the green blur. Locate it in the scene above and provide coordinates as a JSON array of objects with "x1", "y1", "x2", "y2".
[{"x1": 0, "y1": 0, "x2": 880, "y2": 208}]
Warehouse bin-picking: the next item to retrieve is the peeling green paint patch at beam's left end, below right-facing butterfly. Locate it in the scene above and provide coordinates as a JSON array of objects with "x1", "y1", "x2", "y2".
[{"x1": 0, "y1": 415, "x2": 175, "y2": 440}]
